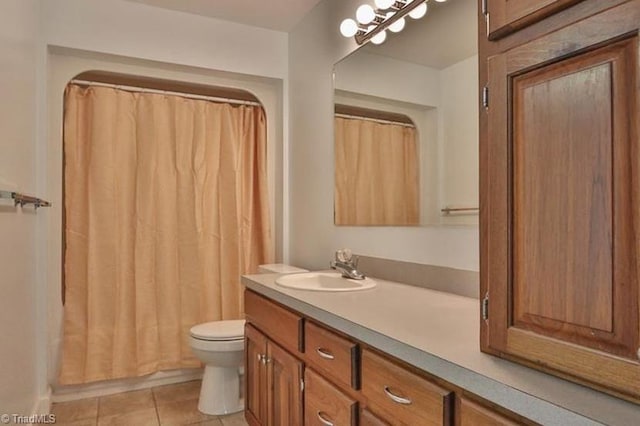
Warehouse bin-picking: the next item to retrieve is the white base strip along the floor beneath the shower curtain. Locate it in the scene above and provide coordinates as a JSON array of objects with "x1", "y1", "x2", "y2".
[{"x1": 50, "y1": 368, "x2": 203, "y2": 402}]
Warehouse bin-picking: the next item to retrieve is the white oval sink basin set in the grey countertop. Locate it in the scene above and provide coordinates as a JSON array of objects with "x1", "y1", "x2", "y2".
[{"x1": 276, "y1": 272, "x2": 376, "y2": 291}]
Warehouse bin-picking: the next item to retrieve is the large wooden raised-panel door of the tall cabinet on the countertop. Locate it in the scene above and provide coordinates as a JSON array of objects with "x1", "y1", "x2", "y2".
[{"x1": 481, "y1": 1, "x2": 640, "y2": 400}]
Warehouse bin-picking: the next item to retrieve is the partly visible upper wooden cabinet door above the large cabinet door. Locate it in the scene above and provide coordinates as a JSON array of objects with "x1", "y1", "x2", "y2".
[{"x1": 485, "y1": 0, "x2": 582, "y2": 40}]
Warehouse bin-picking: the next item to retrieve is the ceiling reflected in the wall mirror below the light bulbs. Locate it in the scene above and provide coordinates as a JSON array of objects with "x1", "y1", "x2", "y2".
[{"x1": 360, "y1": 0, "x2": 478, "y2": 69}]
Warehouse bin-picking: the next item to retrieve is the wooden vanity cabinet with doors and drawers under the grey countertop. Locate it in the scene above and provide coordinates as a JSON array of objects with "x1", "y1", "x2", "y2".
[{"x1": 245, "y1": 290, "x2": 524, "y2": 426}]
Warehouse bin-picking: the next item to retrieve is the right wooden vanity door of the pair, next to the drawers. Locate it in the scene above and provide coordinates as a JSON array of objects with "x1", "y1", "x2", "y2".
[{"x1": 266, "y1": 342, "x2": 302, "y2": 426}]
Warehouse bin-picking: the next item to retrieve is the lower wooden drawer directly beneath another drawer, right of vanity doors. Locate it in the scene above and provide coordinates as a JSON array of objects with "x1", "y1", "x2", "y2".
[{"x1": 304, "y1": 368, "x2": 358, "y2": 426}]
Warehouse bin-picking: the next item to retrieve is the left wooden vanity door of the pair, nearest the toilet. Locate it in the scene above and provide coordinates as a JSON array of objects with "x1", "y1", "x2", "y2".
[{"x1": 244, "y1": 324, "x2": 267, "y2": 425}]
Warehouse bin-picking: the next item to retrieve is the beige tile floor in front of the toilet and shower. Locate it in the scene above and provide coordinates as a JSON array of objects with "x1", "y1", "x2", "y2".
[{"x1": 51, "y1": 380, "x2": 247, "y2": 426}]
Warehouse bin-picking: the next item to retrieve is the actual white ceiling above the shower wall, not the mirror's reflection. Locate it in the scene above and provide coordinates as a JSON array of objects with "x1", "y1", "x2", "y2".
[{"x1": 127, "y1": 0, "x2": 321, "y2": 32}]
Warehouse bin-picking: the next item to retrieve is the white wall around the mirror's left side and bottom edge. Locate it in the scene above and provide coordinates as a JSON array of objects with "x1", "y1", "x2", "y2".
[{"x1": 289, "y1": 0, "x2": 479, "y2": 271}]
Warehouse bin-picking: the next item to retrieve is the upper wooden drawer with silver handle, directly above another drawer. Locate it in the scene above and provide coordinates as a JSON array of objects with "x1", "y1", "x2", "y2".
[{"x1": 304, "y1": 322, "x2": 360, "y2": 389}]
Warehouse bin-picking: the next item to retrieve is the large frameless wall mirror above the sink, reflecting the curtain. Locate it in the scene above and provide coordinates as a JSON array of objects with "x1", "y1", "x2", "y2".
[{"x1": 334, "y1": 0, "x2": 479, "y2": 226}]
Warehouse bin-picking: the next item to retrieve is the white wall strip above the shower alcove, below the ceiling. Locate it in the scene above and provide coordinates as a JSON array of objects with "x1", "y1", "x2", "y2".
[{"x1": 43, "y1": 0, "x2": 287, "y2": 78}]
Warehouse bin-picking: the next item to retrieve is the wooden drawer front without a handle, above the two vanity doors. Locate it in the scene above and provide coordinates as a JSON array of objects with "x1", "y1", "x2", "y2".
[{"x1": 244, "y1": 290, "x2": 303, "y2": 352}]
